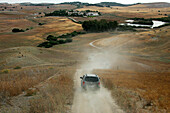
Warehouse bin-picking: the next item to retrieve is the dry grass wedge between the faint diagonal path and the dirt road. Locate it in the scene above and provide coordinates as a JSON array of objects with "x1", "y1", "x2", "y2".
[{"x1": 29, "y1": 67, "x2": 74, "y2": 113}]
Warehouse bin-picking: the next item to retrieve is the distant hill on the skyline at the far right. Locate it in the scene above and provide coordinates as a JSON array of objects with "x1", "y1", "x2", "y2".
[{"x1": 143, "y1": 2, "x2": 170, "y2": 8}]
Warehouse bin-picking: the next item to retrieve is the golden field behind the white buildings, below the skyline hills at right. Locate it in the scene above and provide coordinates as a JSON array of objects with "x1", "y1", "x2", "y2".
[{"x1": 78, "y1": 4, "x2": 170, "y2": 19}]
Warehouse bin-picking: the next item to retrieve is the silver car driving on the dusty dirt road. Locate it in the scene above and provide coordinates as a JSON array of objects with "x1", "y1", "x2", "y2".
[{"x1": 80, "y1": 74, "x2": 100, "y2": 90}]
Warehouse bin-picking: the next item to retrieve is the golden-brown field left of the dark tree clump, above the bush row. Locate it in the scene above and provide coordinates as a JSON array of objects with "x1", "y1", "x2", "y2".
[{"x1": 0, "y1": 17, "x2": 82, "y2": 49}]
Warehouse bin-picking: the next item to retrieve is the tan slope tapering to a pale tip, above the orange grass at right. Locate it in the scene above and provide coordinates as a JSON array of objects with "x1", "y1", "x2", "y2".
[{"x1": 95, "y1": 26, "x2": 170, "y2": 64}]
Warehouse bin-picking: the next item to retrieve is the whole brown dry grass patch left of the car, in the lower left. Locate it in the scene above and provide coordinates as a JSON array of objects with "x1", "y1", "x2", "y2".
[{"x1": 0, "y1": 66, "x2": 74, "y2": 113}]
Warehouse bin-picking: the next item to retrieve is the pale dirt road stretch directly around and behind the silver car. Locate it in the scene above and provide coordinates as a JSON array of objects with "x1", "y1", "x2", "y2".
[{"x1": 72, "y1": 69, "x2": 123, "y2": 113}]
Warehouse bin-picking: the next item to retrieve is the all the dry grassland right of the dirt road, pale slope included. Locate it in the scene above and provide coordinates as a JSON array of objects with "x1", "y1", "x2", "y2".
[{"x1": 89, "y1": 26, "x2": 170, "y2": 113}]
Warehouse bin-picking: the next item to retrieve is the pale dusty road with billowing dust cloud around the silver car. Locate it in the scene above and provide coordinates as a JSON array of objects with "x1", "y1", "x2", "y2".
[{"x1": 72, "y1": 49, "x2": 124, "y2": 113}]
